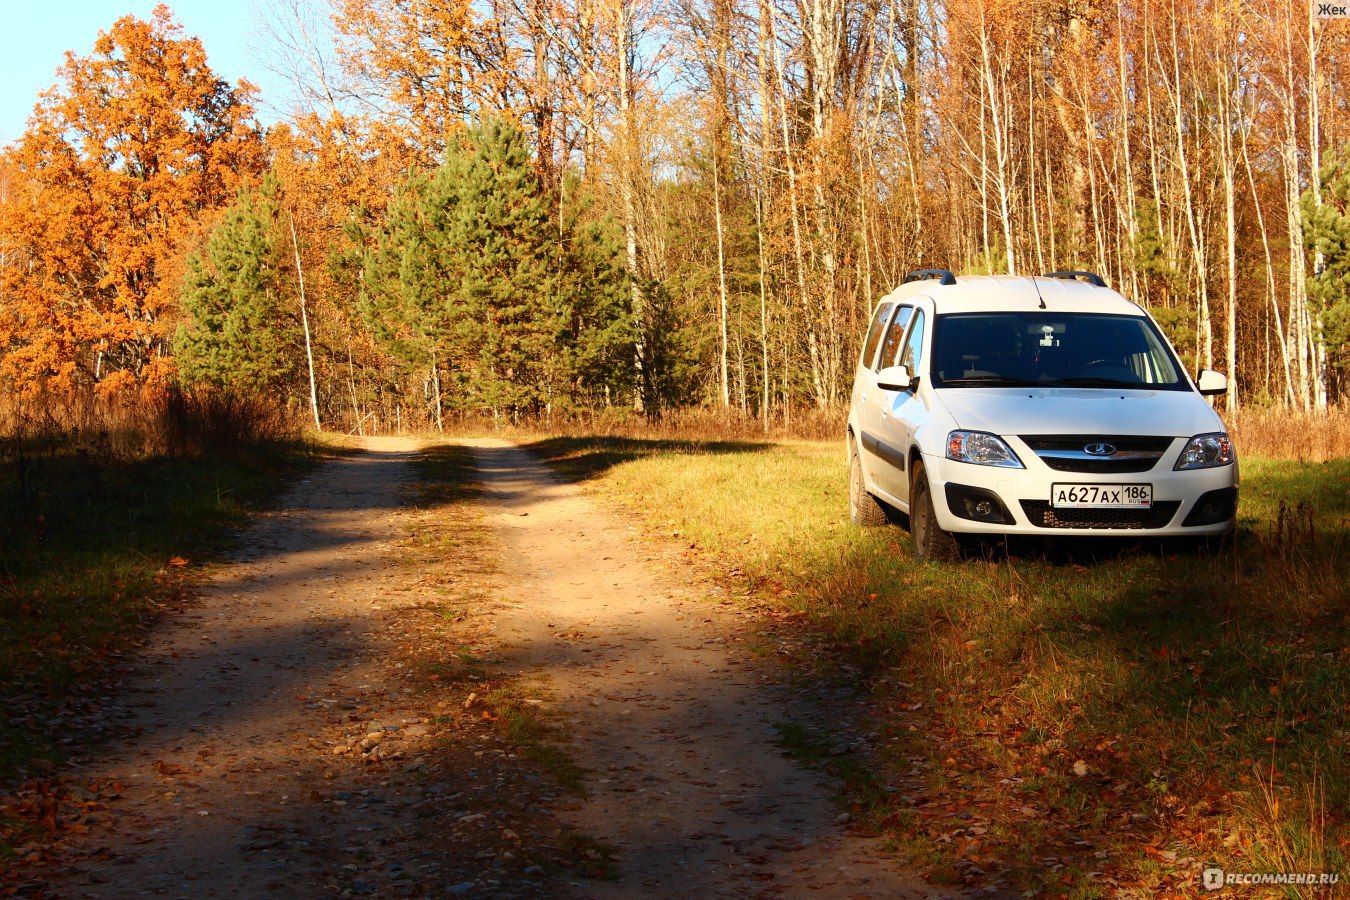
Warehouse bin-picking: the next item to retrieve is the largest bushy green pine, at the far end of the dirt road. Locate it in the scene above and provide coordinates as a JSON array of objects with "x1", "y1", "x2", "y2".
[{"x1": 362, "y1": 121, "x2": 630, "y2": 416}]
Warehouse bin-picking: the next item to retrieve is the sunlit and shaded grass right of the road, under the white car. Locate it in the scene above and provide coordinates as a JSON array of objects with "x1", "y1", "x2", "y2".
[{"x1": 533, "y1": 439, "x2": 1350, "y2": 896}]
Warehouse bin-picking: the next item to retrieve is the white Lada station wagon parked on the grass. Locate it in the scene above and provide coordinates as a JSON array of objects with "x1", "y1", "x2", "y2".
[{"x1": 848, "y1": 269, "x2": 1238, "y2": 561}]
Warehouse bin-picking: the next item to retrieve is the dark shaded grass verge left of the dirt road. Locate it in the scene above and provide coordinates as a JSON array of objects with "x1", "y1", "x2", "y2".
[{"x1": 0, "y1": 443, "x2": 321, "y2": 779}]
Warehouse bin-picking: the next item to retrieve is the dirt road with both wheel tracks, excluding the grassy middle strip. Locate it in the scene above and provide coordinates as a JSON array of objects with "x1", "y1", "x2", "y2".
[{"x1": 31, "y1": 440, "x2": 932, "y2": 897}]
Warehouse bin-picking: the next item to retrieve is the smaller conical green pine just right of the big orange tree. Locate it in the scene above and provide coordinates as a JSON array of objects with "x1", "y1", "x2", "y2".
[{"x1": 174, "y1": 174, "x2": 300, "y2": 393}]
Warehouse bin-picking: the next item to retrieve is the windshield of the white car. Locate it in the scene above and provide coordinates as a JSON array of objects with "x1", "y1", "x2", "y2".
[{"x1": 930, "y1": 312, "x2": 1189, "y2": 390}]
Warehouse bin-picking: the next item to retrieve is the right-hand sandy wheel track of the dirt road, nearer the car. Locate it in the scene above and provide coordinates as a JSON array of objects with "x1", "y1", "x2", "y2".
[{"x1": 474, "y1": 441, "x2": 933, "y2": 897}]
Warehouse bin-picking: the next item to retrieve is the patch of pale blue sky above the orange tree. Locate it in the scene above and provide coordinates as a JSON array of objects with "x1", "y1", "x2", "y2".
[{"x1": 0, "y1": 0, "x2": 297, "y2": 146}]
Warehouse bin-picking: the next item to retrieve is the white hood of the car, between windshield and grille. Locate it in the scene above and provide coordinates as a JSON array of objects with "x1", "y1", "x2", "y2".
[{"x1": 936, "y1": 387, "x2": 1223, "y2": 437}]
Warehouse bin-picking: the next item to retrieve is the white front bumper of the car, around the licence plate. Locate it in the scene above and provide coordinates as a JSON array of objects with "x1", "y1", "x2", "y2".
[{"x1": 923, "y1": 453, "x2": 1238, "y2": 537}]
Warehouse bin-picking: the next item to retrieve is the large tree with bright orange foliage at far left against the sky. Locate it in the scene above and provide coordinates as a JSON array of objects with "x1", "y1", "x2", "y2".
[{"x1": 0, "y1": 5, "x2": 265, "y2": 391}]
